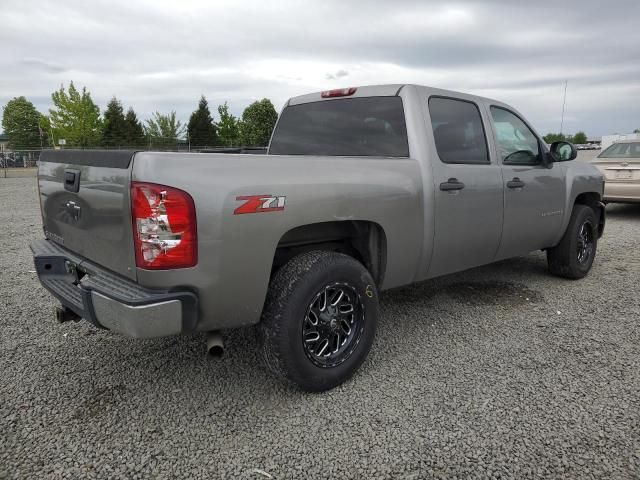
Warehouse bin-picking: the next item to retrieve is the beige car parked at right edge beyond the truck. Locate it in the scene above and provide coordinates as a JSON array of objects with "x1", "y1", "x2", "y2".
[{"x1": 592, "y1": 140, "x2": 640, "y2": 203}]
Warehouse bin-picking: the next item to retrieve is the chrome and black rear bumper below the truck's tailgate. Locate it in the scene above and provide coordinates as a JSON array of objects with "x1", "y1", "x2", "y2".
[{"x1": 30, "y1": 239, "x2": 198, "y2": 338}]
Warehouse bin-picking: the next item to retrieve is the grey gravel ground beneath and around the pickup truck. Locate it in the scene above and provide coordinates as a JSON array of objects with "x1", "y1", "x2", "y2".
[{"x1": 0, "y1": 178, "x2": 640, "y2": 479}]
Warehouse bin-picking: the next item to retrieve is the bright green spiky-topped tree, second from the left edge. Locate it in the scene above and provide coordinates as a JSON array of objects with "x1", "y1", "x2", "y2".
[{"x1": 49, "y1": 82, "x2": 102, "y2": 147}]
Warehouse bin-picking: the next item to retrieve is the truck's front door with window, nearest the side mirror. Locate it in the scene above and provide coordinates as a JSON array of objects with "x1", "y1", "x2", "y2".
[{"x1": 489, "y1": 105, "x2": 566, "y2": 259}]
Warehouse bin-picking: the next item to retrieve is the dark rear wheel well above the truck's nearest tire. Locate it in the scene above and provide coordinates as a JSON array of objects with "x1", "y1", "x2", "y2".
[{"x1": 271, "y1": 220, "x2": 387, "y2": 286}]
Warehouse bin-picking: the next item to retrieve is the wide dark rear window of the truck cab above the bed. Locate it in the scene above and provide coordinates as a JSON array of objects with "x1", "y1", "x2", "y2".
[{"x1": 269, "y1": 97, "x2": 409, "y2": 157}]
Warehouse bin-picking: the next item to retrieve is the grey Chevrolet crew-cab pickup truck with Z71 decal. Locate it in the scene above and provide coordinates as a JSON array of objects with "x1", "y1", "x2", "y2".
[{"x1": 31, "y1": 85, "x2": 605, "y2": 391}]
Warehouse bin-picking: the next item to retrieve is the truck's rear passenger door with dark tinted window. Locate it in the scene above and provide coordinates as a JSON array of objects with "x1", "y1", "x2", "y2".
[{"x1": 425, "y1": 96, "x2": 502, "y2": 277}]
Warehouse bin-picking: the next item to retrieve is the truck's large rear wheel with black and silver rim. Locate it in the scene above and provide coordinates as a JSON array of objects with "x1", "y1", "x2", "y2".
[{"x1": 258, "y1": 251, "x2": 378, "y2": 392}]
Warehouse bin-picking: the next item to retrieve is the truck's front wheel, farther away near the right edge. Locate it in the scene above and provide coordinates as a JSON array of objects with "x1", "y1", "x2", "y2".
[{"x1": 547, "y1": 205, "x2": 598, "y2": 280}]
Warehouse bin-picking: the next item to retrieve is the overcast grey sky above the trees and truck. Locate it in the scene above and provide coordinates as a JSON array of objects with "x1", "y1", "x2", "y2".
[{"x1": 0, "y1": 0, "x2": 640, "y2": 136}]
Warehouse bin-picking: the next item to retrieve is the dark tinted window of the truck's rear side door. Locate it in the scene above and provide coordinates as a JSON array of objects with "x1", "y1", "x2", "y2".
[{"x1": 429, "y1": 97, "x2": 489, "y2": 164}]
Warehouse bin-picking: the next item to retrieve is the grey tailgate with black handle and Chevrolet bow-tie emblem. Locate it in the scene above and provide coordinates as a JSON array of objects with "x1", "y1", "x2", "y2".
[{"x1": 38, "y1": 150, "x2": 136, "y2": 280}]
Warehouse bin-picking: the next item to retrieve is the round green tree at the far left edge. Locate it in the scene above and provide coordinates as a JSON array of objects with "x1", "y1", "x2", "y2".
[{"x1": 2, "y1": 97, "x2": 43, "y2": 149}]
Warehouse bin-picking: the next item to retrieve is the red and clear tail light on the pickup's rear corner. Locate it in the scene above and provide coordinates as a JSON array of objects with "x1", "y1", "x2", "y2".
[{"x1": 131, "y1": 182, "x2": 198, "y2": 270}]
